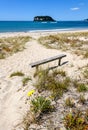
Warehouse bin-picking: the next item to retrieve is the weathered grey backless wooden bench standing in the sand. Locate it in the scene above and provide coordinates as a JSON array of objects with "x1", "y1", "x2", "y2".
[{"x1": 30, "y1": 54, "x2": 66, "y2": 69}]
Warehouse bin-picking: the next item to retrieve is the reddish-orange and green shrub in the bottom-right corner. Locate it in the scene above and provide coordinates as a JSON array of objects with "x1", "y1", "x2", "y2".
[{"x1": 64, "y1": 110, "x2": 88, "y2": 130}]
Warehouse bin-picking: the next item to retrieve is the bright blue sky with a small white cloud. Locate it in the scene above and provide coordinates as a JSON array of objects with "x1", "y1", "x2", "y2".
[{"x1": 0, "y1": 0, "x2": 88, "y2": 21}]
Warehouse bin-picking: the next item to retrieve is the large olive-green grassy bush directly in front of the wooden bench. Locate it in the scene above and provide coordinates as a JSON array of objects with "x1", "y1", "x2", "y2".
[{"x1": 35, "y1": 69, "x2": 70, "y2": 99}]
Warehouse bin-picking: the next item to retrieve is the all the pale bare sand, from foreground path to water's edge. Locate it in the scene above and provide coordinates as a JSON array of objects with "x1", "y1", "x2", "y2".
[{"x1": 0, "y1": 30, "x2": 88, "y2": 130}]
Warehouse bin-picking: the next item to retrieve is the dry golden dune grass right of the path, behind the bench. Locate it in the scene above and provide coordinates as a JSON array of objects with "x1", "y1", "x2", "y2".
[{"x1": 39, "y1": 32, "x2": 88, "y2": 58}]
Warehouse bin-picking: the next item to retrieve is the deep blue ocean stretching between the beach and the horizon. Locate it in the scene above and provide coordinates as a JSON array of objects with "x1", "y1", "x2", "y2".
[{"x1": 0, "y1": 21, "x2": 88, "y2": 33}]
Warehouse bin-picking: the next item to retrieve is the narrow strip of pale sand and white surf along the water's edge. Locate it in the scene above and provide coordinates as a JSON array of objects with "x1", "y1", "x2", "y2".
[{"x1": 0, "y1": 29, "x2": 88, "y2": 38}]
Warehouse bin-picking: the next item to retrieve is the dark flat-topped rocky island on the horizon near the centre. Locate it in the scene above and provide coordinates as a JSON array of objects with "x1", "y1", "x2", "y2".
[{"x1": 34, "y1": 16, "x2": 55, "y2": 22}]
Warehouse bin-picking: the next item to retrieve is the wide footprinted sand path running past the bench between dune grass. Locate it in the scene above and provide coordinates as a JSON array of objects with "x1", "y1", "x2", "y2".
[{"x1": 0, "y1": 37, "x2": 86, "y2": 130}]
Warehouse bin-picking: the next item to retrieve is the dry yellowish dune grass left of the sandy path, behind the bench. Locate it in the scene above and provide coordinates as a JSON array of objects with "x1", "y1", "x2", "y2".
[{"x1": 0, "y1": 36, "x2": 31, "y2": 59}]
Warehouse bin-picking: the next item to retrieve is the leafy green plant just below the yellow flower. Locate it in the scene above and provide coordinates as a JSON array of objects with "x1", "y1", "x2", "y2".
[{"x1": 30, "y1": 96, "x2": 53, "y2": 118}]
